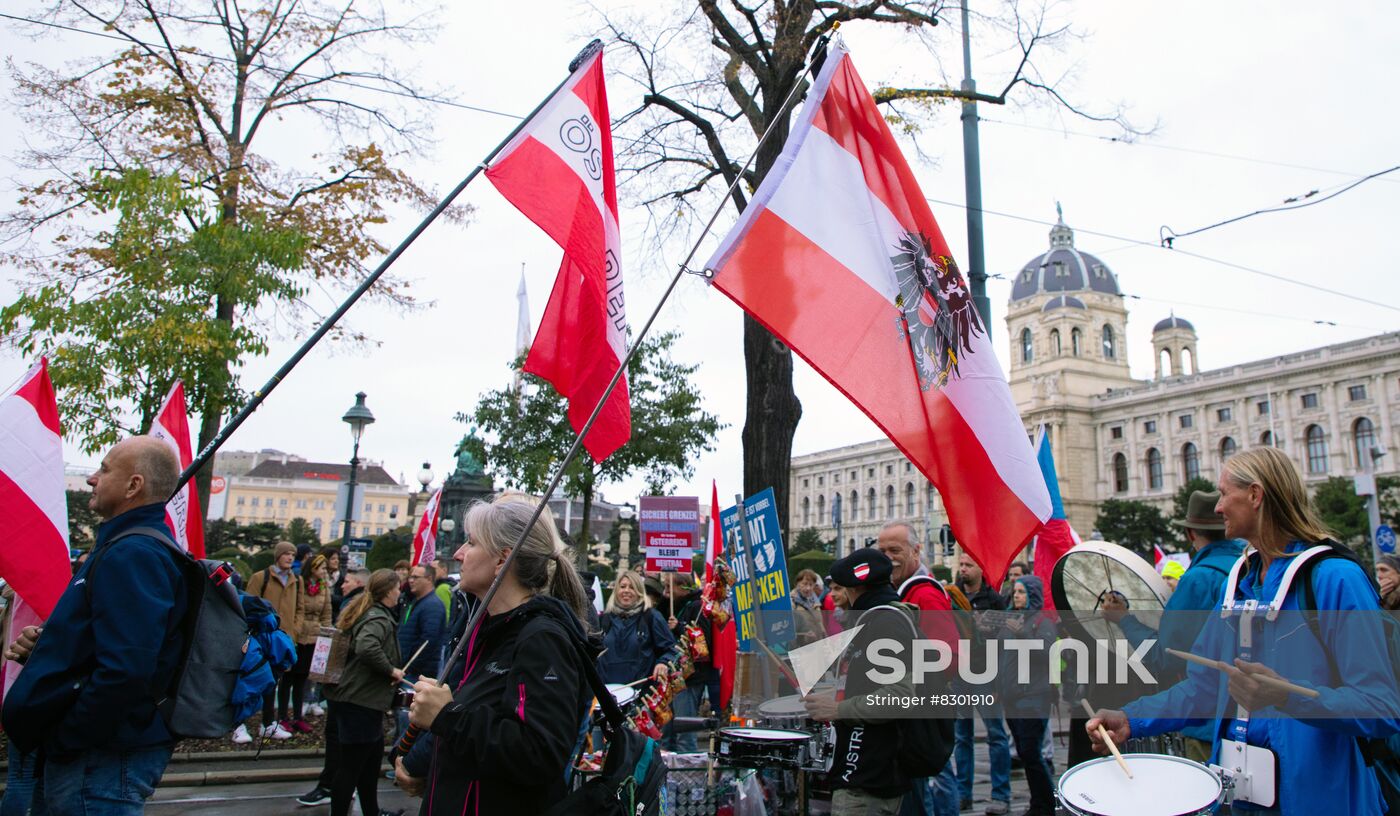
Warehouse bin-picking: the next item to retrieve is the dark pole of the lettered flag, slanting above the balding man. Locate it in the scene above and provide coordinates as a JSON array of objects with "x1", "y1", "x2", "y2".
[{"x1": 172, "y1": 39, "x2": 602, "y2": 495}]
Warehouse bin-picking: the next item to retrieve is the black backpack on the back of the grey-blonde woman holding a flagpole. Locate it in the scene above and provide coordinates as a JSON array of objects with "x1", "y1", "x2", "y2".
[{"x1": 546, "y1": 645, "x2": 666, "y2": 816}]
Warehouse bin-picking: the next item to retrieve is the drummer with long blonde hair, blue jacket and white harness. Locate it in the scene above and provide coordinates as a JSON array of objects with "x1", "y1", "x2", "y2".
[{"x1": 1088, "y1": 448, "x2": 1400, "y2": 816}]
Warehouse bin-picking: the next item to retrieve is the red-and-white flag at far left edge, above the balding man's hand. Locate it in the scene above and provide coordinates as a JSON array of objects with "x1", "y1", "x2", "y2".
[{"x1": 0, "y1": 358, "x2": 73, "y2": 617}]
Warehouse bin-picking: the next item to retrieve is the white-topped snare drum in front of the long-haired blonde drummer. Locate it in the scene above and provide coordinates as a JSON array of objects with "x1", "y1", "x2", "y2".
[{"x1": 1056, "y1": 753, "x2": 1225, "y2": 816}]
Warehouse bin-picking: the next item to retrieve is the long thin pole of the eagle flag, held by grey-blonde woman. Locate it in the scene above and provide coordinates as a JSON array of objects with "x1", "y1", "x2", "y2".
[{"x1": 395, "y1": 38, "x2": 827, "y2": 754}]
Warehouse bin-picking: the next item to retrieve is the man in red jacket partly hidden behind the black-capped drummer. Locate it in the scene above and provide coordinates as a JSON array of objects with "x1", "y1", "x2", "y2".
[{"x1": 875, "y1": 521, "x2": 958, "y2": 816}]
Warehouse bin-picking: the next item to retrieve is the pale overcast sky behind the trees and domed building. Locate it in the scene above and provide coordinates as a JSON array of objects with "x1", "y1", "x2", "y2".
[{"x1": 0, "y1": 0, "x2": 1400, "y2": 501}]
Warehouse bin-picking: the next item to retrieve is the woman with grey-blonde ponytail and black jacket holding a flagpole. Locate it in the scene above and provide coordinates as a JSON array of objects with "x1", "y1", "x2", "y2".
[{"x1": 409, "y1": 494, "x2": 596, "y2": 816}]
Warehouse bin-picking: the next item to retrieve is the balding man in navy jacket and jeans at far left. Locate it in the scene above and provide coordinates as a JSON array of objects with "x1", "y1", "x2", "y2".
[{"x1": 3, "y1": 437, "x2": 186, "y2": 813}]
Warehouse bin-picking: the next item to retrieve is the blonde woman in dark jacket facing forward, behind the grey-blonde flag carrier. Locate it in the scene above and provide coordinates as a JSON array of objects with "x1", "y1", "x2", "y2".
[{"x1": 598, "y1": 570, "x2": 676, "y2": 694}]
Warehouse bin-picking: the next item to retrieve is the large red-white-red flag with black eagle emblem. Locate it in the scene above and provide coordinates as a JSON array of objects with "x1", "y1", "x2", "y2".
[{"x1": 707, "y1": 46, "x2": 1050, "y2": 585}]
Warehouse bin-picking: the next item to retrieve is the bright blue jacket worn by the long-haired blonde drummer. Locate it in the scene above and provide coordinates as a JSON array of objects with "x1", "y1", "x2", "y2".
[{"x1": 1124, "y1": 542, "x2": 1400, "y2": 816}]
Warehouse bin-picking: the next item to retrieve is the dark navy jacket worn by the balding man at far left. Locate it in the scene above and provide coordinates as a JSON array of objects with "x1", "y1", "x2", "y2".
[{"x1": 3, "y1": 504, "x2": 188, "y2": 757}]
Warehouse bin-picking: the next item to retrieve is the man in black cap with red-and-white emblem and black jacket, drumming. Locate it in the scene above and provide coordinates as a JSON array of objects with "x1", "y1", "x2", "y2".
[{"x1": 804, "y1": 547, "x2": 914, "y2": 816}]
